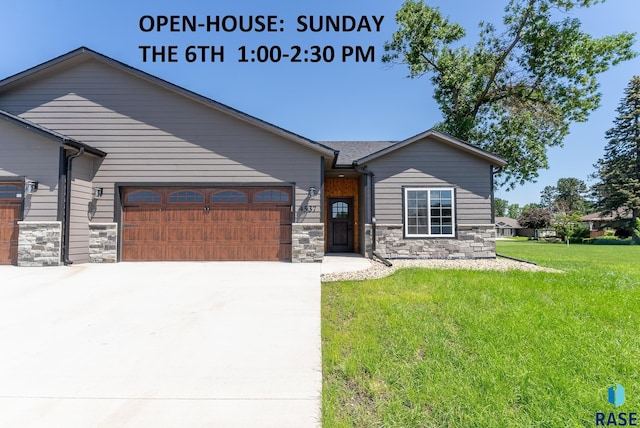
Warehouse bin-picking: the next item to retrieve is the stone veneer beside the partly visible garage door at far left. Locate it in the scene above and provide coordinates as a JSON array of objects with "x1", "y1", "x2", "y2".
[{"x1": 18, "y1": 221, "x2": 62, "y2": 266}]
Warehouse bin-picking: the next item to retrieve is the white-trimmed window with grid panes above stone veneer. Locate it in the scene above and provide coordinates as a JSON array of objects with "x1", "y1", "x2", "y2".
[{"x1": 403, "y1": 187, "x2": 456, "y2": 238}]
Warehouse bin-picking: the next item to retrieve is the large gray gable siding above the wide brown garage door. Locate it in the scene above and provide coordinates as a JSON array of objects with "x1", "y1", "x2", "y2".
[{"x1": 0, "y1": 60, "x2": 321, "y2": 222}]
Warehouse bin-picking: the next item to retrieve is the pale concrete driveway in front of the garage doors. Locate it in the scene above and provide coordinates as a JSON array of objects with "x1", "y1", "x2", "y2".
[{"x1": 0, "y1": 262, "x2": 322, "y2": 428}]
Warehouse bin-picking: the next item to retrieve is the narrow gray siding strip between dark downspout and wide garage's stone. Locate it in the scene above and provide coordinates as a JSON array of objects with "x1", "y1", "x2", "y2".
[{"x1": 69, "y1": 155, "x2": 93, "y2": 263}]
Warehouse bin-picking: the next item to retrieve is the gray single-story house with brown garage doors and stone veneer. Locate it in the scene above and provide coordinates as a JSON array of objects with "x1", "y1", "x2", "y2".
[{"x1": 0, "y1": 48, "x2": 506, "y2": 266}]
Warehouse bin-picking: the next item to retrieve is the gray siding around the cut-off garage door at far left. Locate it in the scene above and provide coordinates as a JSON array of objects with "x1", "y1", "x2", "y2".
[{"x1": 0, "y1": 120, "x2": 59, "y2": 221}]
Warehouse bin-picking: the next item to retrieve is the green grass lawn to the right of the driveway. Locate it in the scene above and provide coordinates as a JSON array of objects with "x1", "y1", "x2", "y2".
[{"x1": 322, "y1": 241, "x2": 640, "y2": 427}]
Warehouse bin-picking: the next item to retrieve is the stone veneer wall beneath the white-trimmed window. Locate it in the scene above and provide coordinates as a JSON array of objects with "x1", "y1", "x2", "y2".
[{"x1": 365, "y1": 224, "x2": 496, "y2": 259}]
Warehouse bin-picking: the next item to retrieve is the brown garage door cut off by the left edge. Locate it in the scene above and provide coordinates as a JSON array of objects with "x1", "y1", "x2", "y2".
[{"x1": 0, "y1": 183, "x2": 22, "y2": 265}]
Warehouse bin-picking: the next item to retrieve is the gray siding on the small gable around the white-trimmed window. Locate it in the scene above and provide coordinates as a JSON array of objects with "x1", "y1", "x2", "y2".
[{"x1": 367, "y1": 139, "x2": 492, "y2": 224}]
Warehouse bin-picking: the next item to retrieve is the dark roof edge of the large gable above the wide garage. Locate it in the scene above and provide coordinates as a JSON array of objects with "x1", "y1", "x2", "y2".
[{"x1": 0, "y1": 47, "x2": 337, "y2": 157}]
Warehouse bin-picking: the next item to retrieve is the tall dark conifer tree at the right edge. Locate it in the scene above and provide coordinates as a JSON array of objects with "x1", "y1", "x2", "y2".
[{"x1": 594, "y1": 76, "x2": 640, "y2": 241}]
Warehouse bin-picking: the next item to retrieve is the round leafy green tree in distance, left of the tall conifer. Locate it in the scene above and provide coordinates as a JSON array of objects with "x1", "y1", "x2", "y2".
[{"x1": 540, "y1": 177, "x2": 589, "y2": 214}]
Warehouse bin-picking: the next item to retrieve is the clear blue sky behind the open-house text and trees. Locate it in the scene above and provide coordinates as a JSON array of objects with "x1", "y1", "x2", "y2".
[{"x1": 0, "y1": 0, "x2": 640, "y2": 205}]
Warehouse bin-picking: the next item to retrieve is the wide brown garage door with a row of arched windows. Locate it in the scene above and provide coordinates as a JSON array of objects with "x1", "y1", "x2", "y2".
[{"x1": 122, "y1": 187, "x2": 291, "y2": 261}]
